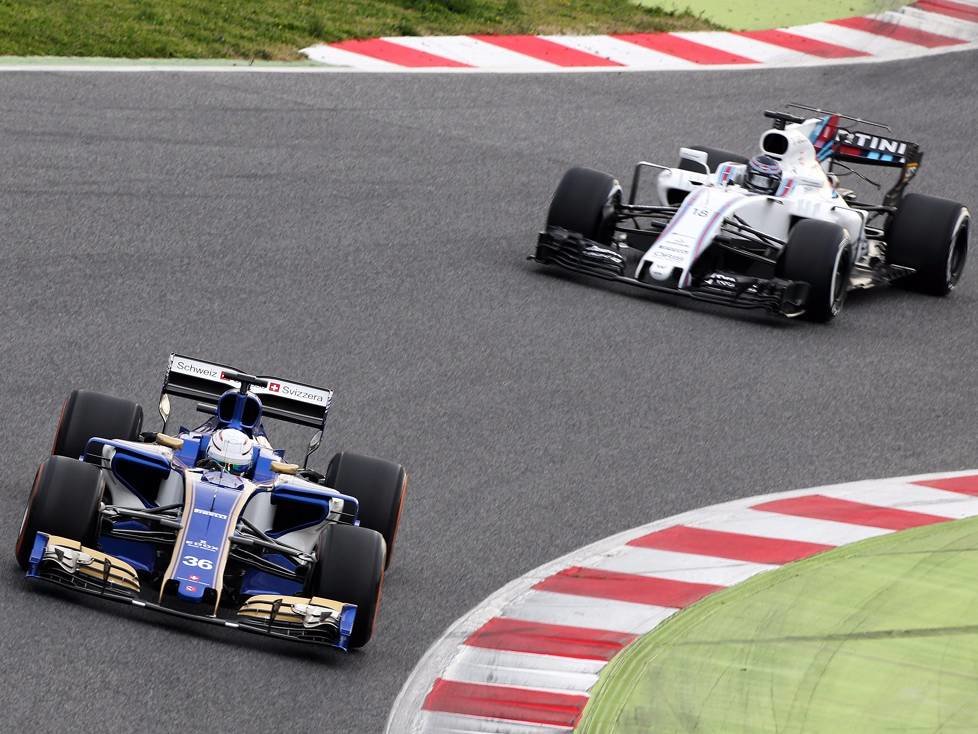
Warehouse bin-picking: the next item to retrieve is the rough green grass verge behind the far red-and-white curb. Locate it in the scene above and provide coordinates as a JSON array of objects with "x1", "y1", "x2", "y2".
[{"x1": 0, "y1": 0, "x2": 710, "y2": 60}]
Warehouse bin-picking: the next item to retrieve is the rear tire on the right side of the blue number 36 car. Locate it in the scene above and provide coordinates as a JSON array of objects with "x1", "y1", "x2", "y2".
[{"x1": 326, "y1": 451, "x2": 407, "y2": 568}]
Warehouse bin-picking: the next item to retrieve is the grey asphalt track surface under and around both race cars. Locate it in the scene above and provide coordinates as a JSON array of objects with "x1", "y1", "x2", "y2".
[{"x1": 0, "y1": 52, "x2": 978, "y2": 732}]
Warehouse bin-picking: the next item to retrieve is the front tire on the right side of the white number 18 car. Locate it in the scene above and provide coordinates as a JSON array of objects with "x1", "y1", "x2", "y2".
[{"x1": 777, "y1": 219, "x2": 852, "y2": 323}]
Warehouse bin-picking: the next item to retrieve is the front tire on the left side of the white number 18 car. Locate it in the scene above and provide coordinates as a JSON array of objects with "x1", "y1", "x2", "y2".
[{"x1": 547, "y1": 168, "x2": 621, "y2": 245}]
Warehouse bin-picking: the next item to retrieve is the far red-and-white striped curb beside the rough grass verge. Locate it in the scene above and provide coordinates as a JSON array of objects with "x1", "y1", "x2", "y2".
[{"x1": 302, "y1": 0, "x2": 978, "y2": 72}]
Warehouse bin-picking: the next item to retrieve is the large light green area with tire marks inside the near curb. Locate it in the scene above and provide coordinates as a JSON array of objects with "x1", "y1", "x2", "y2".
[{"x1": 577, "y1": 519, "x2": 978, "y2": 734}]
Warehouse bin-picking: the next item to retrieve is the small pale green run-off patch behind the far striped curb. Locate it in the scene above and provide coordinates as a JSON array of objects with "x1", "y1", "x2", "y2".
[{"x1": 635, "y1": 0, "x2": 907, "y2": 30}]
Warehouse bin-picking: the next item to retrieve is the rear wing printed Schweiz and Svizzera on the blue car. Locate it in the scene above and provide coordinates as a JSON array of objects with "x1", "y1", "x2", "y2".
[{"x1": 160, "y1": 354, "x2": 333, "y2": 431}]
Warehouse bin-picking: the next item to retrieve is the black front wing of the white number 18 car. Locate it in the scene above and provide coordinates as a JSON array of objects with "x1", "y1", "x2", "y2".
[{"x1": 529, "y1": 227, "x2": 808, "y2": 317}]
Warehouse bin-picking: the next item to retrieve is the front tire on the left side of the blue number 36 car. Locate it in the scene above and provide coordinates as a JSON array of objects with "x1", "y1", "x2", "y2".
[{"x1": 16, "y1": 456, "x2": 105, "y2": 570}]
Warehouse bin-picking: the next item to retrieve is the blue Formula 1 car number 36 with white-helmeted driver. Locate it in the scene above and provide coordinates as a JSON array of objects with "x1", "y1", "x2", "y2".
[{"x1": 16, "y1": 354, "x2": 407, "y2": 650}]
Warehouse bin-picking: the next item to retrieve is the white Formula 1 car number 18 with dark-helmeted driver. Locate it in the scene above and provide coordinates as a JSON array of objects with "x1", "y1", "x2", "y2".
[{"x1": 530, "y1": 105, "x2": 971, "y2": 322}]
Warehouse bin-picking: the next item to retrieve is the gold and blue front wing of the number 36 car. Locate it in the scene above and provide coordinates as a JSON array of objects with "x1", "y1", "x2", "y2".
[{"x1": 27, "y1": 533, "x2": 356, "y2": 650}]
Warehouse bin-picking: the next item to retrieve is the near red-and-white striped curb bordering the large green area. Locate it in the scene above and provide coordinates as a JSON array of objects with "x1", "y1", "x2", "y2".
[{"x1": 386, "y1": 470, "x2": 978, "y2": 734}]
